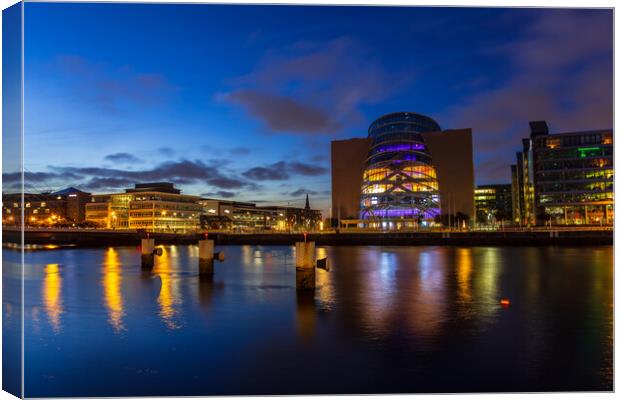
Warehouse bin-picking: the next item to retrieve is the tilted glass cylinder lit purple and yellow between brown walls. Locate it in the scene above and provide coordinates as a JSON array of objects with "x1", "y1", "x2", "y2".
[{"x1": 360, "y1": 112, "x2": 441, "y2": 221}]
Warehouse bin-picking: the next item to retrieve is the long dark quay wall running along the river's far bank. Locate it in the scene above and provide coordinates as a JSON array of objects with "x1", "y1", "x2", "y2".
[{"x1": 2, "y1": 227, "x2": 613, "y2": 247}]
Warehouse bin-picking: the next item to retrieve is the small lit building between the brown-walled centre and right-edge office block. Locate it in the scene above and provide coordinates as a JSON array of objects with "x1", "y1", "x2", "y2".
[{"x1": 474, "y1": 184, "x2": 512, "y2": 225}]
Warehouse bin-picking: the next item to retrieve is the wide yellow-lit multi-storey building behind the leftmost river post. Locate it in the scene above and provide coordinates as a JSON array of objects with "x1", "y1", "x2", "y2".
[{"x1": 85, "y1": 182, "x2": 202, "y2": 232}]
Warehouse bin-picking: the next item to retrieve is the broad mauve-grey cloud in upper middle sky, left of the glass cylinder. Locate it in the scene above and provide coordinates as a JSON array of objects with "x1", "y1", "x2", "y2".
[{"x1": 217, "y1": 37, "x2": 400, "y2": 135}]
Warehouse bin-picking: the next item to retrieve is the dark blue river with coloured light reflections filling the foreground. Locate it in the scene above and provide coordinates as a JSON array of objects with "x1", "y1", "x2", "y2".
[{"x1": 3, "y1": 246, "x2": 613, "y2": 397}]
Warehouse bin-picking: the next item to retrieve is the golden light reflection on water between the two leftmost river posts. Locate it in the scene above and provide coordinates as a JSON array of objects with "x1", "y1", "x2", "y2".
[{"x1": 153, "y1": 246, "x2": 183, "y2": 329}]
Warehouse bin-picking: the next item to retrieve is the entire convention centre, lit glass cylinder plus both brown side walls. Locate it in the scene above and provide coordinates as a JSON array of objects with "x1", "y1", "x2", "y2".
[{"x1": 331, "y1": 112, "x2": 474, "y2": 229}]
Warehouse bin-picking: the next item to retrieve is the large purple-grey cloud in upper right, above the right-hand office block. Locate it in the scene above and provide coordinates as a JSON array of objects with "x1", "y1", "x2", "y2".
[{"x1": 442, "y1": 10, "x2": 613, "y2": 182}]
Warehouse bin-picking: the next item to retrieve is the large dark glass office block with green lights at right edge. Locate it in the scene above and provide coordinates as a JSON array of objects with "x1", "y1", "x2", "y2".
[{"x1": 513, "y1": 121, "x2": 614, "y2": 225}]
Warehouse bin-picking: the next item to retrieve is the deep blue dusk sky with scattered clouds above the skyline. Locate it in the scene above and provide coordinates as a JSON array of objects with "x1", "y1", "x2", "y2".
[{"x1": 19, "y1": 3, "x2": 612, "y2": 210}]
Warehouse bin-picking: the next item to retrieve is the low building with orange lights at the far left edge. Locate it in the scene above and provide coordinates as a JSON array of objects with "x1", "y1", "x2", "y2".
[{"x1": 2, "y1": 187, "x2": 90, "y2": 225}]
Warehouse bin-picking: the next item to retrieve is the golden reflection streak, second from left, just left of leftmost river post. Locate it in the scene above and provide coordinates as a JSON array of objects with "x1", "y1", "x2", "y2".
[{"x1": 101, "y1": 247, "x2": 125, "y2": 333}]
